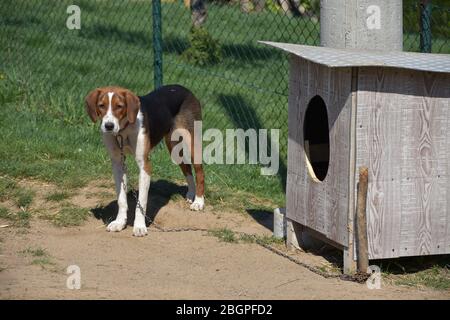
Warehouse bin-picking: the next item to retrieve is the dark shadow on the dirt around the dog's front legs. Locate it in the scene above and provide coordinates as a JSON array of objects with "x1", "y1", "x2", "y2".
[{"x1": 91, "y1": 180, "x2": 187, "y2": 226}]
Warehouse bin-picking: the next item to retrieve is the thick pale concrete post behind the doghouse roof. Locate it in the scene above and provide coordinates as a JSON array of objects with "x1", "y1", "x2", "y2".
[{"x1": 320, "y1": 0, "x2": 403, "y2": 51}]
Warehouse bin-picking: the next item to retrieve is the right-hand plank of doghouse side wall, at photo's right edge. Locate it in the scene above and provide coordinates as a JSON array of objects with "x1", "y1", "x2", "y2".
[{"x1": 400, "y1": 72, "x2": 450, "y2": 256}]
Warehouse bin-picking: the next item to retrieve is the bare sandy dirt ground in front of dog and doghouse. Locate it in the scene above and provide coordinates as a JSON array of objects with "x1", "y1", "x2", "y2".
[{"x1": 0, "y1": 182, "x2": 450, "y2": 299}]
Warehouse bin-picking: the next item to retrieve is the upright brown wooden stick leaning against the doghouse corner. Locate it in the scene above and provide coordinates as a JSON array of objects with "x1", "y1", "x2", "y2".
[{"x1": 356, "y1": 167, "x2": 369, "y2": 273}]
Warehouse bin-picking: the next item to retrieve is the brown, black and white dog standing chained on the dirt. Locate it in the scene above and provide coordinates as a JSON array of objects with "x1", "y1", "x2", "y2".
[{"x1": 85, "y1": 85, "x2": 205, "y2": 237}]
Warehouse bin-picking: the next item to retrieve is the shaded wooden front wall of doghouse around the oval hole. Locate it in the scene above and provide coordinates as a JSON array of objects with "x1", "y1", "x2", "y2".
[{"x1": 287, "y1": 57, "x2": 351, "y2": 246}]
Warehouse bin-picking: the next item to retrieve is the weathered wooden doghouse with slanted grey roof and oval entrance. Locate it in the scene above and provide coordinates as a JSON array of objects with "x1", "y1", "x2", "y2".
[{"x1": 264, "y1": 42, "x2": 450, "y2": 268}]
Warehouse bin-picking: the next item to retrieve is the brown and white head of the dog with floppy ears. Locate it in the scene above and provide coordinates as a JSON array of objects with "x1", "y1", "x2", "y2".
[{"x1": 85, "y1": 87, "x2": 140, "y2": 134}]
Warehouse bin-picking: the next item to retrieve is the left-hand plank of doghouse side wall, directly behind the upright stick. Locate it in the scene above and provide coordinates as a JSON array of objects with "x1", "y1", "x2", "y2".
[{"x1": 355, "y1": 68, "x2": 401, "y2": 259}]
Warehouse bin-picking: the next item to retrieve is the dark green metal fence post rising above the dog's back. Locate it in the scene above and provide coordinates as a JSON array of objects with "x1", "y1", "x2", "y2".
[{"x1": 152, "y1": 0, "x2": 163, "y2": 89}]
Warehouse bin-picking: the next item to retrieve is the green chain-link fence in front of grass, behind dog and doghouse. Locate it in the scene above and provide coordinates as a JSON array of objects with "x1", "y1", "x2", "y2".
[{"x1": 0, "y1": 0, "x2": 450, "y2": 188}]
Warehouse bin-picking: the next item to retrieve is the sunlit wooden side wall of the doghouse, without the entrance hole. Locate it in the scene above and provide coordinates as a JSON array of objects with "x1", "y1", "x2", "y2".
[{"x1": 357, "y1": 68, "x2": 450, "y2": 259}]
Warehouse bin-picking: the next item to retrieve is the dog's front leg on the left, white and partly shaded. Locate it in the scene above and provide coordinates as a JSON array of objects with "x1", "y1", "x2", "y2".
[{"x1": 103, "y1": 136, "x2": 128, "y2": 232}]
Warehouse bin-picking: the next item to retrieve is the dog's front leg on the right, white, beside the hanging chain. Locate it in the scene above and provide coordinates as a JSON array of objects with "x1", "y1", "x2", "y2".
[{"x1": 133, "y1": 129, "x2": 151, "y2": 237}]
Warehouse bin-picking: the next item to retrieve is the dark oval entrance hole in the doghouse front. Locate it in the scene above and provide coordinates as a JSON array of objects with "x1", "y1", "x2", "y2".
[{"x1": 303, "y1": 96, "x2": 330, "y2": 181}]
